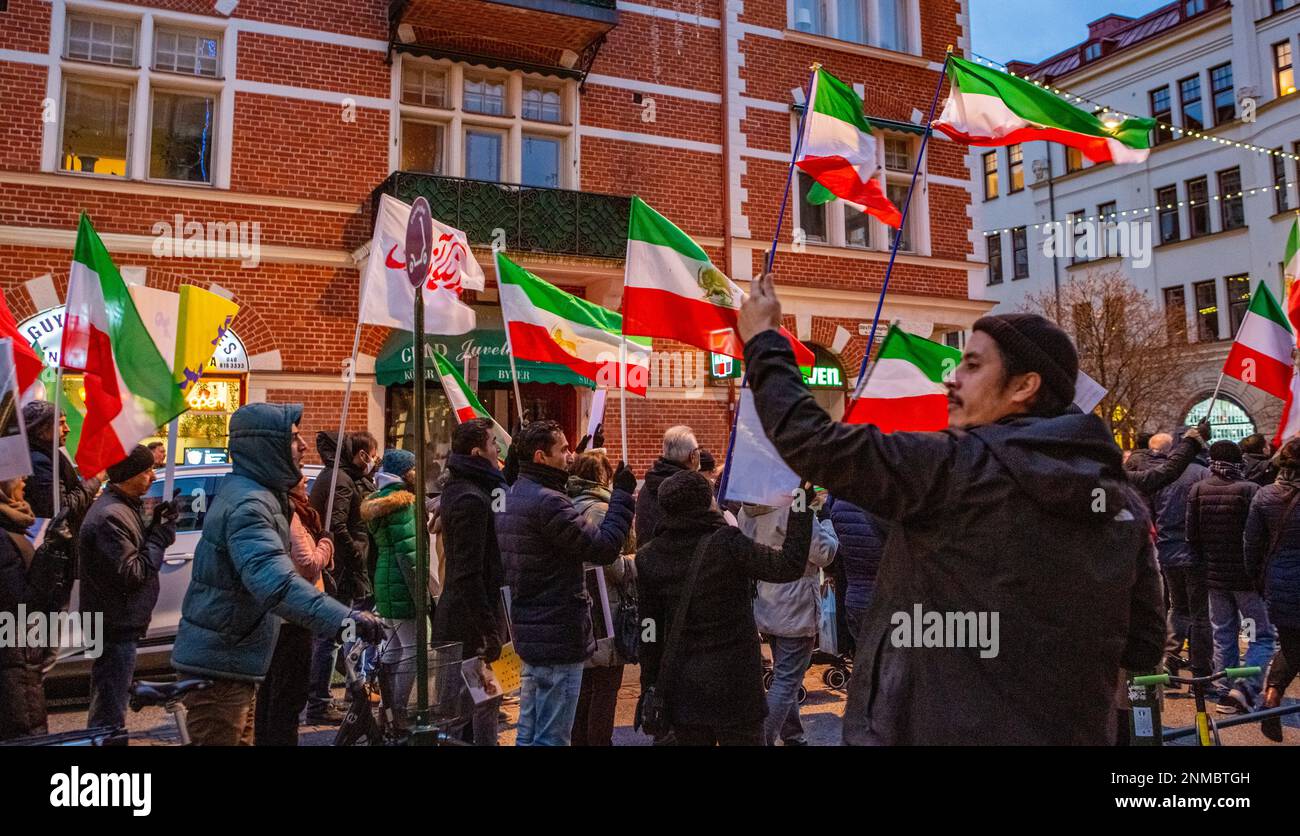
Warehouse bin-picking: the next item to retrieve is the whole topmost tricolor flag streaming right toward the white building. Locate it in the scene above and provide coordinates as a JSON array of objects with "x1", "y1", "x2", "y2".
[{"x1": 935, "y1": 56, "x2": 1156, "y2": 163}]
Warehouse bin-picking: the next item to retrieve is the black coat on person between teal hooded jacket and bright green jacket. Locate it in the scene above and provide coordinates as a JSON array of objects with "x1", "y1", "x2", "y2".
[{"x1": 308, "y1": 432, "x2": 374, "y2": 603}]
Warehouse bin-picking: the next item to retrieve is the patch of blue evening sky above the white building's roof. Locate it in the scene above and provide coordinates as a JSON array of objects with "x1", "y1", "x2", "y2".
[{"x1": 970, "y1": 0, "x2": 1169, "y2": 61}]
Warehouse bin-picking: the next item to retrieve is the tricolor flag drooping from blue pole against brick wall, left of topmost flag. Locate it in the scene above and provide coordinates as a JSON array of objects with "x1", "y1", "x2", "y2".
[{"x1": 794, "y1": 66, "x2": 902, "y2": 228}]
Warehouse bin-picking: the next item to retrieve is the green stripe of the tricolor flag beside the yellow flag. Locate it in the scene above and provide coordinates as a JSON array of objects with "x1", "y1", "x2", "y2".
[{"x1": 73, "y1": 213, "x2": 185, "y2": 425}]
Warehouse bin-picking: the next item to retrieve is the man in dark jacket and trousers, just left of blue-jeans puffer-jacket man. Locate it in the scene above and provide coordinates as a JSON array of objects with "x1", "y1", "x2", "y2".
[{"x1": 1151, "y1": 433, "x2": 1214, "y2": 676}]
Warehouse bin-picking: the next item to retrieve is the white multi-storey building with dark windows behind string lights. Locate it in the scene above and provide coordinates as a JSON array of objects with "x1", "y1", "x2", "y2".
[{"x1": 969, "y1": 0, "x2": 1300, "y2": 438}]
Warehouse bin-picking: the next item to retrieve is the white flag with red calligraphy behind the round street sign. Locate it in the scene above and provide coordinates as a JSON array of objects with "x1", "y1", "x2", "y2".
[{"x1": 360, "y1": 195, "x2": 484, "y2": 334}]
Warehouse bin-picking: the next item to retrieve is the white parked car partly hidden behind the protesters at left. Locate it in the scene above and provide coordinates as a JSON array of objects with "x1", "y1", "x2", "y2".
[{"x1": 47, "y1": 464, "x2": 321, "y2": 693}]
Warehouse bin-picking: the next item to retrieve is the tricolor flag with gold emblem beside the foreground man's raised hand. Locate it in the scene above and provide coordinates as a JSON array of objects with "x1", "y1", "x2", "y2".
[{"x1": 623, "y1": 196, "x2": 814, "y2": 367}]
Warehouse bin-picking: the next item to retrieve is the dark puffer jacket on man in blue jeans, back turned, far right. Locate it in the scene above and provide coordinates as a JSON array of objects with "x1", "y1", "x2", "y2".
[{"x1": 1187, "y1": 473, "x2": 1260, "y2": 592}]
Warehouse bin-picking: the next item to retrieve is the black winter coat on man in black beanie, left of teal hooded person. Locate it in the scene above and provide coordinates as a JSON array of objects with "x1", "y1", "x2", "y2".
[{"x1": 79, "y1": 485, "x2": 176, "y2": 641}]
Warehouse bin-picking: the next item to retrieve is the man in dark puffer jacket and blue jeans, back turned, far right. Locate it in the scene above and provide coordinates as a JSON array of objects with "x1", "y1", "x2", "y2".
[{"x1": 1187, "y1": 441, "x2": 1274, "y2": 714}]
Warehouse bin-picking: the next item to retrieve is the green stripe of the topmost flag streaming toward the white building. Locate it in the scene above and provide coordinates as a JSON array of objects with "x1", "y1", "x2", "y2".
[{"x1": 948, "y1": 56, "x2": 1156, "y2": 148}]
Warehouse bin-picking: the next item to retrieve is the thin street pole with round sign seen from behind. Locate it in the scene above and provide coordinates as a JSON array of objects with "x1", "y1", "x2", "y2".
[{"x1": 406, "y1": 198, "x2": 433, "y2": 735}]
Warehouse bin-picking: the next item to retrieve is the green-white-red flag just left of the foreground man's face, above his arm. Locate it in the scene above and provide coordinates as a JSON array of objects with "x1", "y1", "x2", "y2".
[{"x1": 844, "y1": 325, "x2": 962, "y2": 433}]
